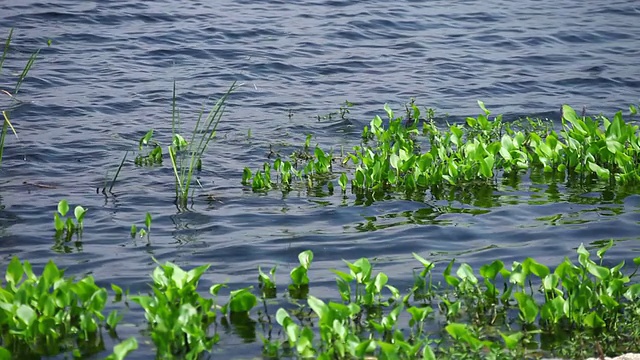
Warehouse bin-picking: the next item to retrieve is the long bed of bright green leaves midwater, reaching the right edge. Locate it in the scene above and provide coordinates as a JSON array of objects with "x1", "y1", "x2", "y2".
[{"x1": 242, "y1": 101, "x2": 640, "y2": 197}]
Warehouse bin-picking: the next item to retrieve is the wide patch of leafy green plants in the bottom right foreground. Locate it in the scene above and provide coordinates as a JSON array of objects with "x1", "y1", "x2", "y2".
[{"x1": 265, "y1": 242, "x2": 640, "y2": 359}]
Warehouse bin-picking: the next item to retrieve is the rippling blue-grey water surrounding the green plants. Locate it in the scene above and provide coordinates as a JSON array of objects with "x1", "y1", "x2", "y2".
[{"x1": 0, "y1": 0, "x2": 640, "y2": 359}]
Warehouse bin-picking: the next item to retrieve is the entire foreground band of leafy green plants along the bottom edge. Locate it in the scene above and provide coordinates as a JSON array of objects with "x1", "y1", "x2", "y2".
[{"x1": 0, "y1": 241, "x2": 640, "y2": 359}]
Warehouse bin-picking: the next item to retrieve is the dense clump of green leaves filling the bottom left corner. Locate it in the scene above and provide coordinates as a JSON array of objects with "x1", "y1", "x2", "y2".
[{"x1": 0, "y1": 257, "x2": 120, "y2": 358}]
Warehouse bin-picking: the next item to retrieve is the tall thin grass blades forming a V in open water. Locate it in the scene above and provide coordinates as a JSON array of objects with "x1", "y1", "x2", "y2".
[{"x1": 169, "y1": 82, "x2": 236, "y2": 205}]
